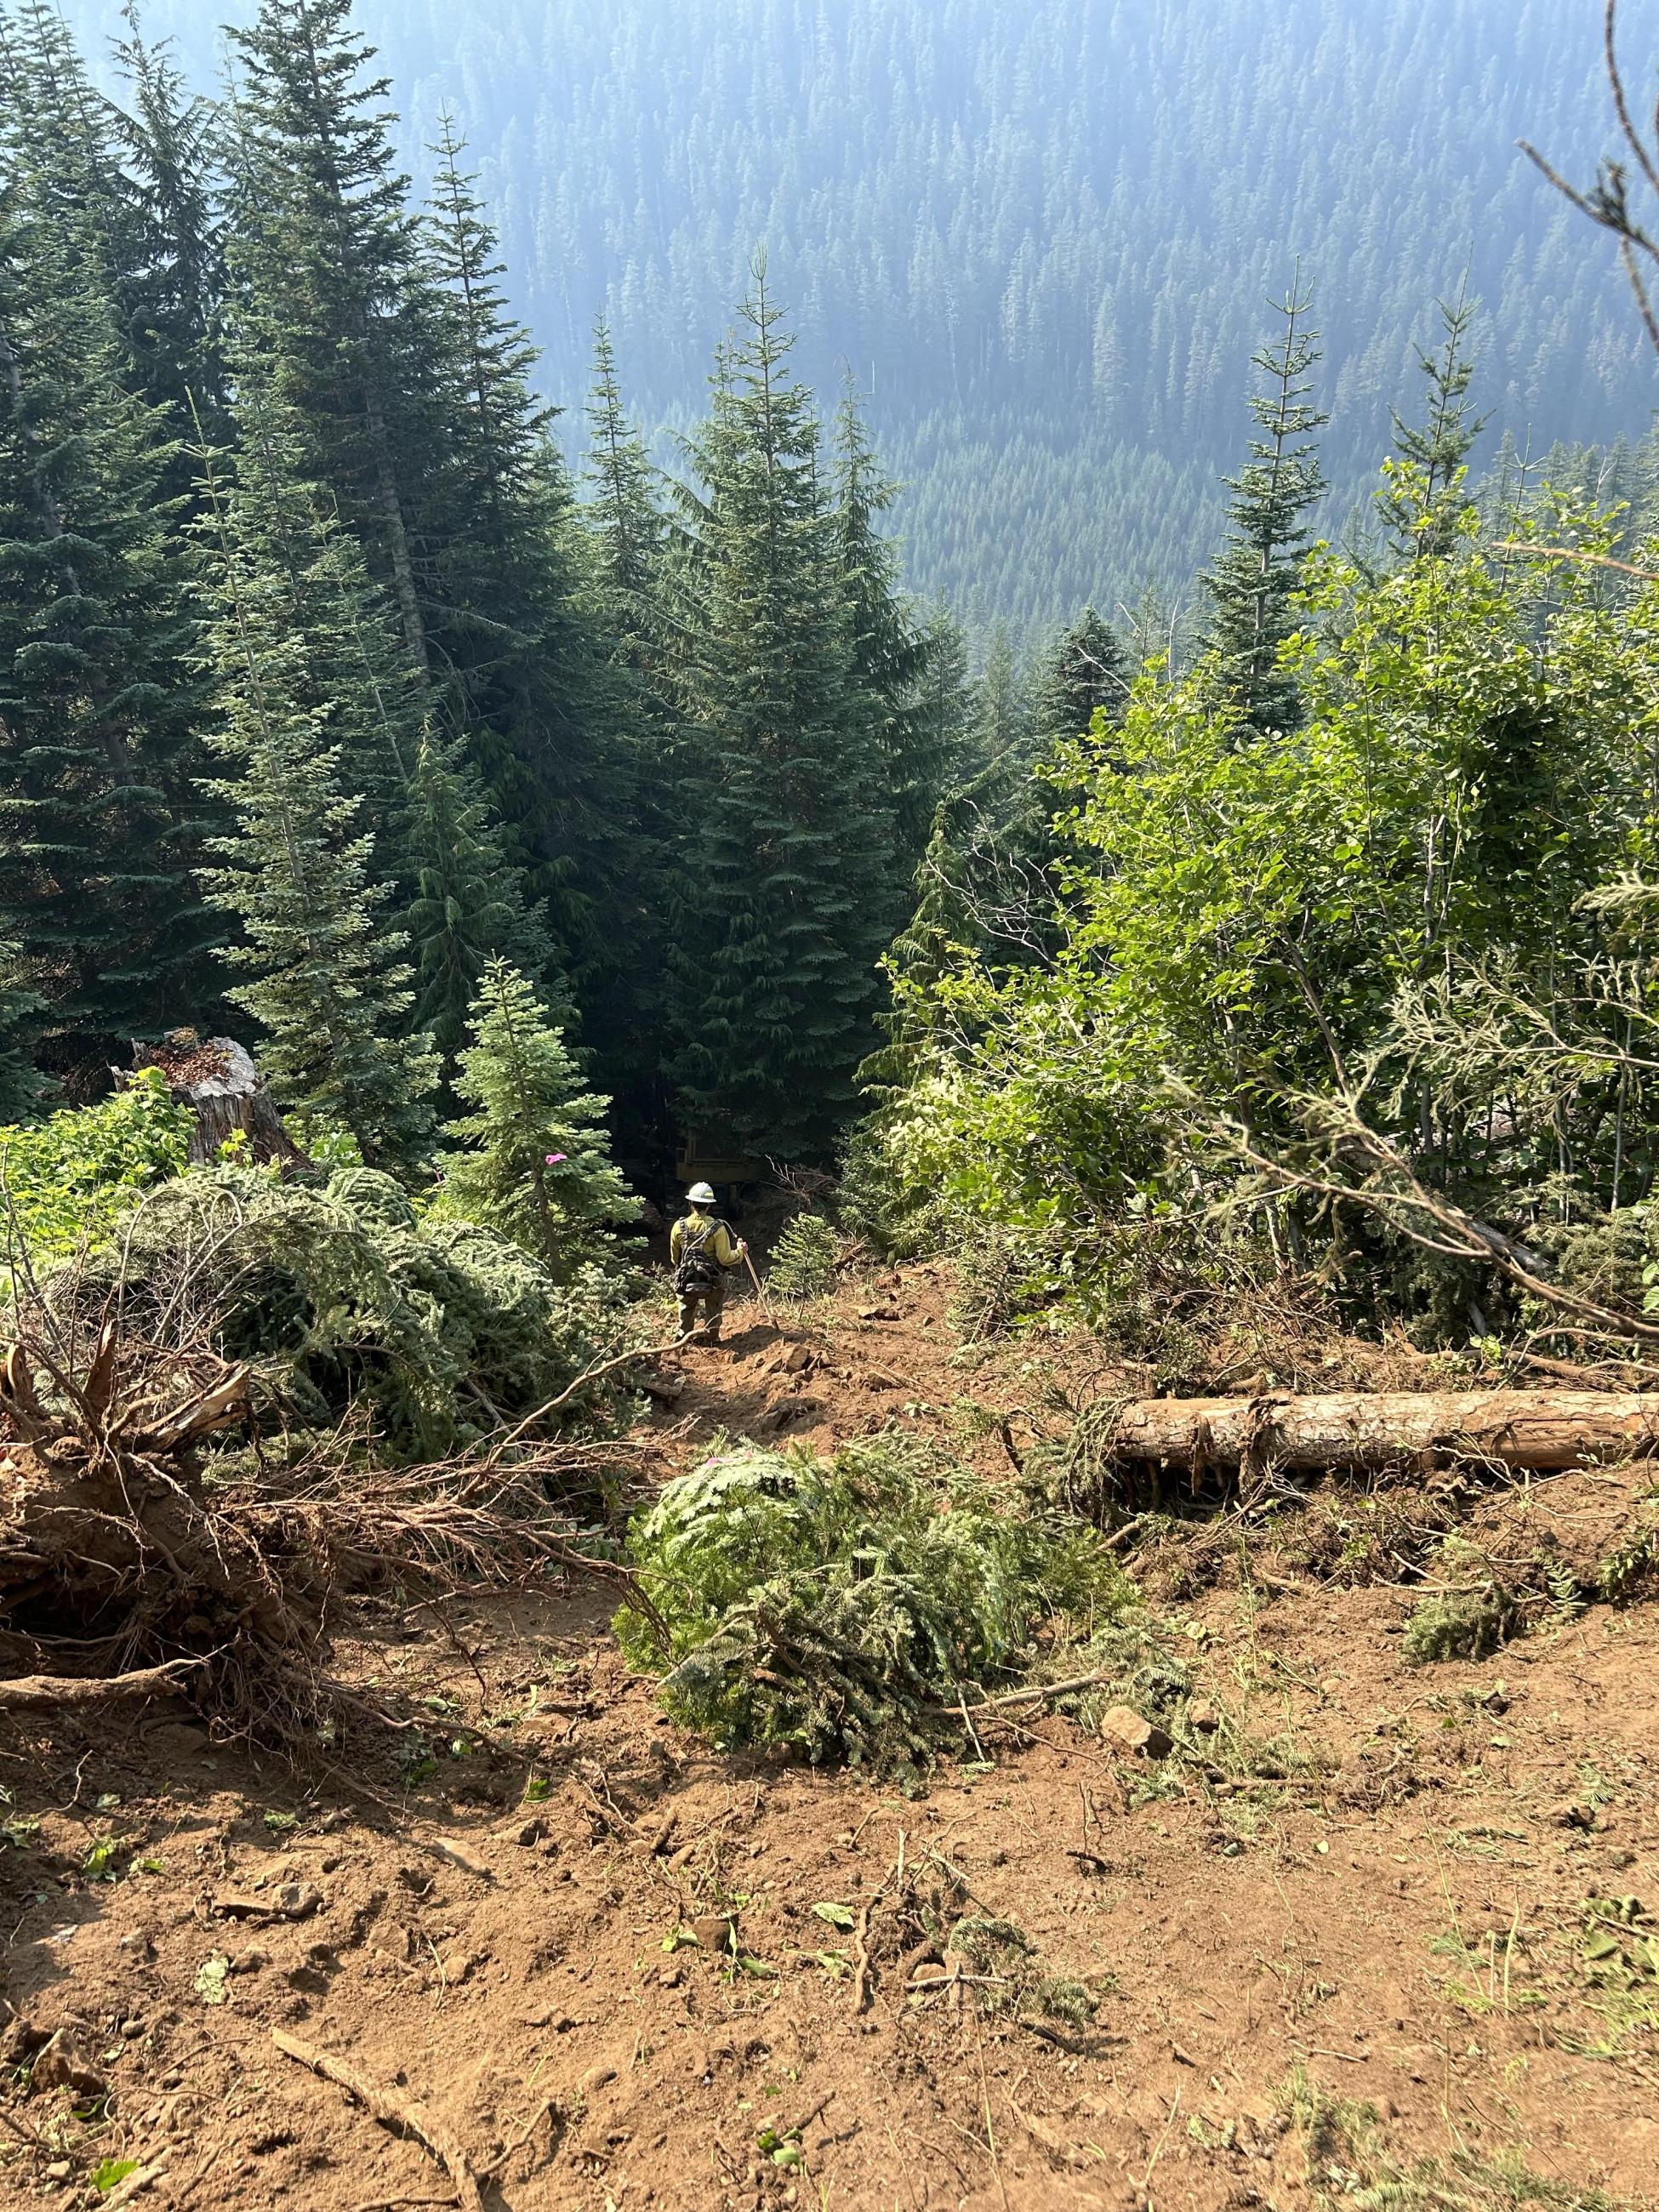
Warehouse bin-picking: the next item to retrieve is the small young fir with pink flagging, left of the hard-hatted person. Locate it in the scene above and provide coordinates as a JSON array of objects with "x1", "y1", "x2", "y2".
[{"x1": 442, "y1": 960, "x2": 635, "y2": 1279}]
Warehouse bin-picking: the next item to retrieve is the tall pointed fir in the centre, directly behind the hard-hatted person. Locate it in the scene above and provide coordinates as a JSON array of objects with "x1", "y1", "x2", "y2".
[{"x1": 668, "y1": 261, "x2": 893, "y2": 1157}]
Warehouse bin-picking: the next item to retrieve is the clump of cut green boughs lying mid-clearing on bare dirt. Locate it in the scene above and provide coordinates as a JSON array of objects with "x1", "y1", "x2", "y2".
[{"x1": 617, "y1": 1438, "x2": 1132, "y2": 1770}]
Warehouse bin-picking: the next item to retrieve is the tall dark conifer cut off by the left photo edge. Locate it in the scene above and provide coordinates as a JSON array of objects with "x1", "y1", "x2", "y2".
[{"x1": 0, "y1": 47, "x2": 219, "y2": 1081}]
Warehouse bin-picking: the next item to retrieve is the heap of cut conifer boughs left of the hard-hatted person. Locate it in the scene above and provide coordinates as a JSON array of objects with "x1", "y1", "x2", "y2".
[{"x1": 68, "y1": 1166, "x2": 622, "y2": 1457}]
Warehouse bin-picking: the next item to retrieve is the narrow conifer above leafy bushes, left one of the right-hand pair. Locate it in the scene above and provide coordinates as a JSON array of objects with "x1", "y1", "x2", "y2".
[{"x1": 1203, "y1": 281, "x2": 1330, "y2": 730}]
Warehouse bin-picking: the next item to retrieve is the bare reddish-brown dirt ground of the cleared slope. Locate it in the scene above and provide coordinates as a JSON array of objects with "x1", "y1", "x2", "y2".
[{"x1": 0, "y1": 1268, "x2": 1659, "y2": 2212}]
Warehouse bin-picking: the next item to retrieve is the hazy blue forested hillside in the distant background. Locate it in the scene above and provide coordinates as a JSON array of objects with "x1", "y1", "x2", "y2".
[{"x1": 66, "y1": 0, "x2": 1659, "y2": 626}]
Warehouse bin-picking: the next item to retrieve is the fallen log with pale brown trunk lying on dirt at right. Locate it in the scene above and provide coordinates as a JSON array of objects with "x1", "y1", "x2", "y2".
[{"x1": 1109, "y1": 1389, "x2": 1659, "y2": 1474}]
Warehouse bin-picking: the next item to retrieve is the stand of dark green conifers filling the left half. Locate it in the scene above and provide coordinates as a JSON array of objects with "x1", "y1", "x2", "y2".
[{"x1": 0, "y1": 0, "x2": 969, "y2": 1167}]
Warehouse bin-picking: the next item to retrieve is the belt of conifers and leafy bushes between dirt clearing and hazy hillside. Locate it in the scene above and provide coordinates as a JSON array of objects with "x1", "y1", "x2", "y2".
[{"x1": 0, "y1": 0, "x2": 1659, "y2": 1371}]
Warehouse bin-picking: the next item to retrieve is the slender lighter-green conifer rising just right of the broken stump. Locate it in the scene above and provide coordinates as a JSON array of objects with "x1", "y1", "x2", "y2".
[{"x1": 194, "y1": 436, "x2": 438, "y2": 1164}]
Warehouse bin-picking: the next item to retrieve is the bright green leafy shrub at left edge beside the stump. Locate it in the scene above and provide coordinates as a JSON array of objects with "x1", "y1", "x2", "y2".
[{"x1": 0, "y1": 1069, "x2": 195, "y2": 1268}]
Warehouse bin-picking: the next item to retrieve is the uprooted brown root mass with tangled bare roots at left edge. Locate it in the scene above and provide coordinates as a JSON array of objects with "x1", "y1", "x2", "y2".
[{"x1": 0, "y1": 1303, "x2": 664, "y2": 1750}]
